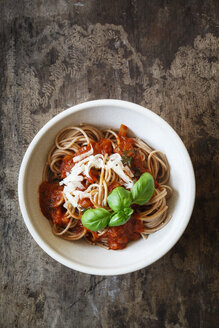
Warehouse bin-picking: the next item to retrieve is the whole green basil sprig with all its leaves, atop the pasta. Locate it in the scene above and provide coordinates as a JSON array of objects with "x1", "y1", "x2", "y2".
[{"x1": 81, "y1": 172, "x2": 154, "y2": 231}]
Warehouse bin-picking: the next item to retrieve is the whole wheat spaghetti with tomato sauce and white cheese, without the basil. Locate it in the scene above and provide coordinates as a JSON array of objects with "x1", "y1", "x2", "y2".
[{"x1": 39, "y1": 124, "x2": 172, "y2": 249}]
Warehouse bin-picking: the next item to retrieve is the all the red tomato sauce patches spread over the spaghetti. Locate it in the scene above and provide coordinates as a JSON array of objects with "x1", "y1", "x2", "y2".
[{"x1": 39, "y1": 124, "x2": 158, "y2": 250}]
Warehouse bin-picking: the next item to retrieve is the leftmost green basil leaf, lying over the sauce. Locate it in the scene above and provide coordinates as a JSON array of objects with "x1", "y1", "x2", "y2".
[{"x1": 81, "y1": 208, "x2": 111, "y2": 231}]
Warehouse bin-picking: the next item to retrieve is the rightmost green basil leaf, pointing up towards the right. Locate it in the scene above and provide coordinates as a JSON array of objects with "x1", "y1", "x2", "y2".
[{"x1": 131, "y1": 172, "x2": 154, "y2": 205}]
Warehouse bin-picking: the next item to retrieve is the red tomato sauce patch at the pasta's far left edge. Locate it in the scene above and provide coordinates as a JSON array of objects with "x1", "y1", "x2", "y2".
[{"x1": 39, "y1": 182, "x2": 69, "y2": 226}]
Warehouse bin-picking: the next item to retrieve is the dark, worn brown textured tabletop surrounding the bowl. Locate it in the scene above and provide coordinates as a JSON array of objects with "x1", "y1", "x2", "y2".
[{"x1": 0, "y1": 0, "x2": 219, "y2": 328}]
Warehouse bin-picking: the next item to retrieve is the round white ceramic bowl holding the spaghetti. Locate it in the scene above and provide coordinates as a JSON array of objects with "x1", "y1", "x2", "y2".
[{"x1": 18, "y1": 100, "x2": 195, "y2": 275}]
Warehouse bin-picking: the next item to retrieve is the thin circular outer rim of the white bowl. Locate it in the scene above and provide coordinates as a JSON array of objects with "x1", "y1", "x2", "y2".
[{"x1": 18, "y1": 99, "x2": 196, "y2": 275}]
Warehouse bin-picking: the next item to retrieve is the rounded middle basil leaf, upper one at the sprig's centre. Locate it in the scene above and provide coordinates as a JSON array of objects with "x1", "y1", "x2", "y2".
[{"x1": 107, "y1": 187, "x2": 132, "y2": 211}]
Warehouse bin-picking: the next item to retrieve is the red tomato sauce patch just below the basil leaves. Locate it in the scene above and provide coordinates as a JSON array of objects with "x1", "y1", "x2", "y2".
[{"x1": 99, "y1": 216, "x2": 144, "y2": 250}]
